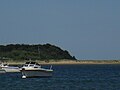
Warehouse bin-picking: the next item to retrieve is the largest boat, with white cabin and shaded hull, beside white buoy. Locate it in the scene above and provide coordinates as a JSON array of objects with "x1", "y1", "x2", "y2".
[{"x1": 21, "y1": 62, "x2": 53, "y2": 78}]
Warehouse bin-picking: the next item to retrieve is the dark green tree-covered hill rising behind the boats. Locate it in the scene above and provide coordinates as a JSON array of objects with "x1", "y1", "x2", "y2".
[{"x1": 0, "y1": 44, "x2": 76, "y2": 60}]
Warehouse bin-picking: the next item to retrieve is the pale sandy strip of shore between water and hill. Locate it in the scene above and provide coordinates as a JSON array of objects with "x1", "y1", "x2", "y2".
[{"x1": 2, "y1": 60, "x2": 120, "y2": 65}]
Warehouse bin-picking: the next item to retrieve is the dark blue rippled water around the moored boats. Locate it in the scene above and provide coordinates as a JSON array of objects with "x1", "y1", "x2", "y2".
[{"x1": 0, "y1": 65, "x2": 120, "y2": 90}]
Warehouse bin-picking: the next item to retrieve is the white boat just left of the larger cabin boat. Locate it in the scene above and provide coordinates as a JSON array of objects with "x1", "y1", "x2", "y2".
[{"x1": 0, "y1": 63, "x2": 20, "y2": 72}]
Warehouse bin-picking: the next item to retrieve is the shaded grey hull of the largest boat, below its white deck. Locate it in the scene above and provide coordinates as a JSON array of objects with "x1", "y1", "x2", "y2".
[{"x1": 21, "y1": 70, "x2": 52, "y2": 78}]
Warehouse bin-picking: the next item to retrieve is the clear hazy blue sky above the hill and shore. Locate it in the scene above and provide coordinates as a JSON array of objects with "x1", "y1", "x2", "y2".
[{"x1": 0, "y1": 0, "x2": 120, "y2": 60}]
